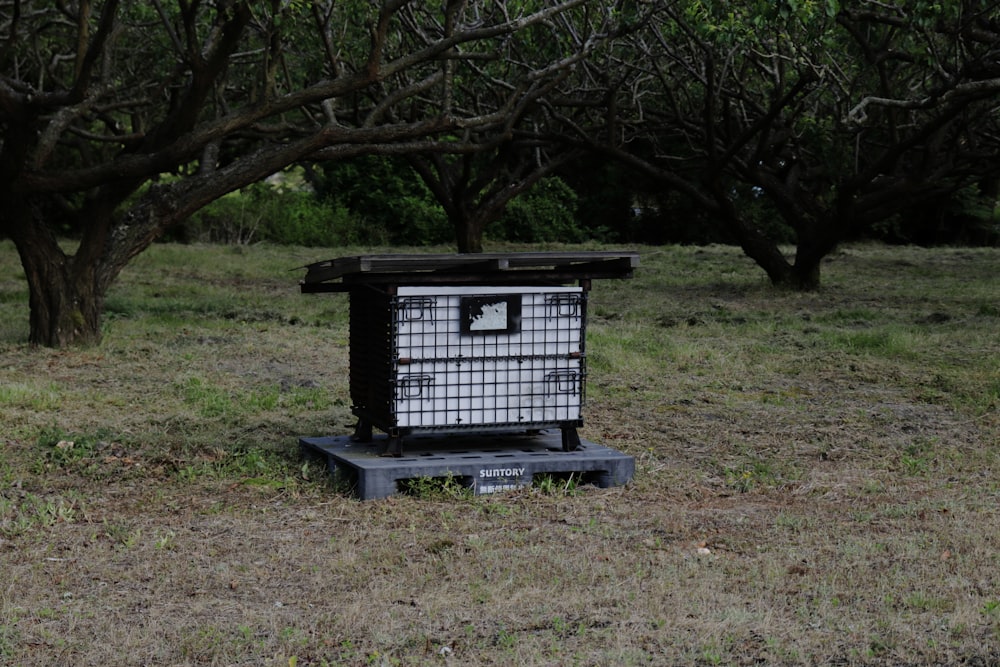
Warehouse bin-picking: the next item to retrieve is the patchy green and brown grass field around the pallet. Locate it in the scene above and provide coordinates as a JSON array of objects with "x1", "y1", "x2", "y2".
[{"x1": 0, "y1": 242, "x2": 1000, "y2": 667}]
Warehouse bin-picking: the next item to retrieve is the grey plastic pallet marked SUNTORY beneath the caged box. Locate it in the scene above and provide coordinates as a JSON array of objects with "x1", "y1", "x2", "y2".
[{"x1": 299, "y1": 430, "x2": 635, "y2": 500}]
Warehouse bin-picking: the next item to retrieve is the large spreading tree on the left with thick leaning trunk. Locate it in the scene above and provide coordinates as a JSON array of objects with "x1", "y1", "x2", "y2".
[{"x1": 0, "y1": 0, "x2": 610, "y2": 345}]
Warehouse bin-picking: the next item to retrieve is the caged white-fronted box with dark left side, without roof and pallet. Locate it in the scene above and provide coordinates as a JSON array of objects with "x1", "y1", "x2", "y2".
[{"x1": 351, "y1": 286, "x2": 587, "y2": 433}]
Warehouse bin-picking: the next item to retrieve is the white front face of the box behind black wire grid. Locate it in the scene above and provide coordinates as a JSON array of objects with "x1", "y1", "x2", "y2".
[{"x1": 392, "y1": 287, "x2": 586, "y2": 428}]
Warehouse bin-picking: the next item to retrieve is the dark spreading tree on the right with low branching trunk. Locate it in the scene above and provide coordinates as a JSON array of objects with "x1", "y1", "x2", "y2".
[{"x1": 554, "y1": 0, "x2": 1000, "y2": 288}]
